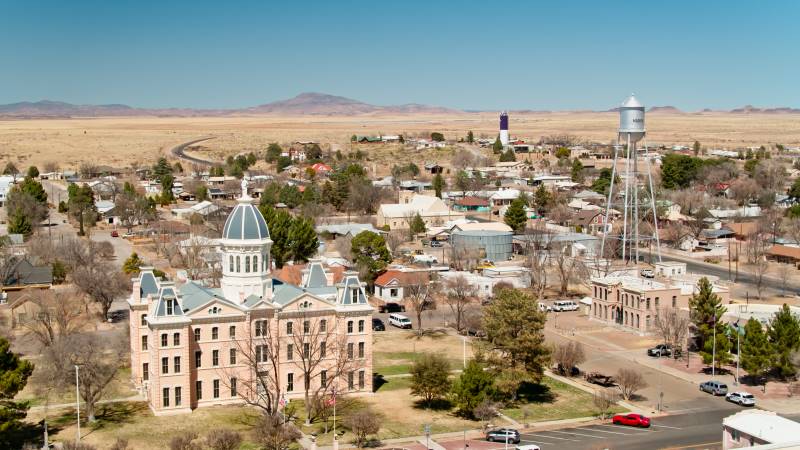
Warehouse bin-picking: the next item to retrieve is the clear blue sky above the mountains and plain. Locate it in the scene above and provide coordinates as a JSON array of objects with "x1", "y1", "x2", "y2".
[{"x1": 0, "y1": 0, "x2": 800, "y2": 110}]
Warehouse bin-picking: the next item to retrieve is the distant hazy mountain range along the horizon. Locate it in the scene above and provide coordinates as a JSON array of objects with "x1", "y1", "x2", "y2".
[{"x1": 0, "y1": 92, "x2": 800, "y2": 119}]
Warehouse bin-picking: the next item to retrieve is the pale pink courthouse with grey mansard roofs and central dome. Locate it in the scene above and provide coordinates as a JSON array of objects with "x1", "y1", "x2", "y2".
[{"x1": 128, "y1": 185, "x2": 373, "y2": 415}]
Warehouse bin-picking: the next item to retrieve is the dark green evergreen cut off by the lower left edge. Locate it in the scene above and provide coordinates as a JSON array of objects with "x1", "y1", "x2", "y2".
[{"x1": 0, "y1": 337, "x2": 33, "y2": 448}]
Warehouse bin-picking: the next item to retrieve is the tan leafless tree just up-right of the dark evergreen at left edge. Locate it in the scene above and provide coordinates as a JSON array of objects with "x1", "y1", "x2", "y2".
[{"x1": 22, "y1": 289, "x2": 86, "y2": 347}]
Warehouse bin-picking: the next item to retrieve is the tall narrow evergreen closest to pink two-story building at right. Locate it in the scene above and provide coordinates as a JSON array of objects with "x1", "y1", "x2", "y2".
[{"x1": 689, "y1": 277, "x2": 731, "y2": 367}]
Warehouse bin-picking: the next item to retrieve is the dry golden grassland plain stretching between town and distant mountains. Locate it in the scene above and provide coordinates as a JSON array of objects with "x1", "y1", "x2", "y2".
[{"x1": 0, "y1": 112, "x2": 800, "y2": 168}]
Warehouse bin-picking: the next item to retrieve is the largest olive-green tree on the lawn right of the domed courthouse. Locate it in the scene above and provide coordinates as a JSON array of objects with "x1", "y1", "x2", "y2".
[{"x1": 483, "y1": 289, "x2": 551, "y2": 391}]
